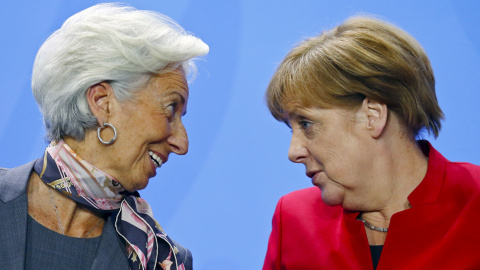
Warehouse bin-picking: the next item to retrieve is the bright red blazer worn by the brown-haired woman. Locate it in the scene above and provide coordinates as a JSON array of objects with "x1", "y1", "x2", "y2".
[{"x1": 263, "y1": 142, "x2": 480, "y2": 270}]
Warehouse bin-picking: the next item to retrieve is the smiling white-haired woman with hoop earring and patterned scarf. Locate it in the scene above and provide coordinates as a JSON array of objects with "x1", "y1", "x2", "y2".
[{"x1": 0, "y1": 4, "x2": 208, "y2": 269}]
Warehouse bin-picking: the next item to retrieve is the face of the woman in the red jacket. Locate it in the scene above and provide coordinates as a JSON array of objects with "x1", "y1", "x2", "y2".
[{"x1": 288, "y1": 105, "x2": 376, "y2": 209}]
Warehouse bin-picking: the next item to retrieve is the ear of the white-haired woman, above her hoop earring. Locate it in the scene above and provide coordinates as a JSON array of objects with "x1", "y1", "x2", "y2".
[{"x1": 87, "y1": 82, "x2": 114, "y2": 126}]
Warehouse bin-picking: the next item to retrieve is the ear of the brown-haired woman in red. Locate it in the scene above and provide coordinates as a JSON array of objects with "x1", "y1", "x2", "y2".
[{"x1": 362, "y1": 98, "x2": 388, "y2": 138}]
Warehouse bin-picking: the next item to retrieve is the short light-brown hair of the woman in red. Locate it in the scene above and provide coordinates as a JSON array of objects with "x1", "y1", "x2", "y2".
[{"x1": 266, "y1": 16, "x2": 444, "y2": 137}]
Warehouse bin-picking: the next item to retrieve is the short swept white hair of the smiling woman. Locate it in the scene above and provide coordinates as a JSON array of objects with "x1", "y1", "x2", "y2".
[{"x1": 32, "y1": 3, "x2": 209, "y2": 141}]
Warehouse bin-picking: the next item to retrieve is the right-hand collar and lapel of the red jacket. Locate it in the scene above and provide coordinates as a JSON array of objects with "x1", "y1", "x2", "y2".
[{"x1": 377, "y1": 141, "x2": 446, "y2": 270}]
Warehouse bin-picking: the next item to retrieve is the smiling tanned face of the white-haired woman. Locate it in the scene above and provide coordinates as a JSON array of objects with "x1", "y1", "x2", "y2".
[{"x1": 106, "y1": 69, "x2": 188, "y2": 191}]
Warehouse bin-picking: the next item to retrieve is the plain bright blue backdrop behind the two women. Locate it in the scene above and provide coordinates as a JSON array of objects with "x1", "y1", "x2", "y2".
[{"x1": 0, "y1": 0, "x2": 480, "y2": 270}]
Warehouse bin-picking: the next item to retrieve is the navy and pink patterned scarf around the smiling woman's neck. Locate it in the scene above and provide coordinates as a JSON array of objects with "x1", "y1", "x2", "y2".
[{"x1": 34, "y1": 140, "x2": 185, "y2": 270}]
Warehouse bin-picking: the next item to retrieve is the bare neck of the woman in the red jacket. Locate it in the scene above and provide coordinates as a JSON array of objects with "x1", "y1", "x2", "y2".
[{"x1": 351, "y1": 124, "x2": 428, "y2": 245}]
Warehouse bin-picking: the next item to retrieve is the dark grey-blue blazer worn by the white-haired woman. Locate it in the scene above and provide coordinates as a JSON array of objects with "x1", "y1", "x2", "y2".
[{"x1": 0, "y1": 161, "x2": 192, "y2": 270}]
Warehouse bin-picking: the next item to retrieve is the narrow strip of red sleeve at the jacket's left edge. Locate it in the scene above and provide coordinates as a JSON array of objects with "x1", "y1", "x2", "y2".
[{"x1": 263, "y1": 198, "x2": 283, "y2": 270}]
